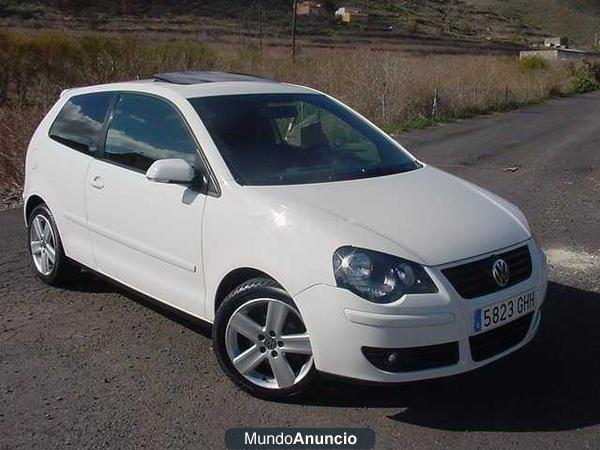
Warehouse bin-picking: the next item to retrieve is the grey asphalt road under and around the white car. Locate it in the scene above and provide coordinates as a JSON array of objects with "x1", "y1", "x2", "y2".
[{"x1": 0, "y1": 94, "x2": 600, "y2": 448}]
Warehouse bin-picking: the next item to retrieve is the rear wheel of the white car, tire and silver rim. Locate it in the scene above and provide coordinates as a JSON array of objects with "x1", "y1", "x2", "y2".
[{"x1": 27, "y1": 204, "x2": 77, "y2": 286}]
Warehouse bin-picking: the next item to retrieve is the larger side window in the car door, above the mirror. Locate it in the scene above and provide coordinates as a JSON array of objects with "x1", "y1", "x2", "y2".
[{"x1": 104, "y1": 94, "x2": 198, "y2": 172}]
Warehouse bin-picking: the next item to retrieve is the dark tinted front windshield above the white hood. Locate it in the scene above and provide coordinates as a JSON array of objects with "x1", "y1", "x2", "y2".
[{"x1": 190, "y1": 94, "x2": 420, "y2": 185}]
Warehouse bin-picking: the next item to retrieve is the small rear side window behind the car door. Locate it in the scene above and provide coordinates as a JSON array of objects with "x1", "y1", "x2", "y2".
[{"x1": 49, "y1": 92, "x2": 113, "y2": 154}]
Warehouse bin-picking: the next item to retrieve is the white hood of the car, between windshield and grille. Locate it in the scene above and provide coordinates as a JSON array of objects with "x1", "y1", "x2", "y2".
[{"x1": 251, "y1": 166, "x2": 531, "y2": 266}]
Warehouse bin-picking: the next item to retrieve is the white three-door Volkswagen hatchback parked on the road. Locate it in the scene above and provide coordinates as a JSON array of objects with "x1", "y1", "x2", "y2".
[{"x1": 24, "y1": 72, "x2": 547, "y2": 399}]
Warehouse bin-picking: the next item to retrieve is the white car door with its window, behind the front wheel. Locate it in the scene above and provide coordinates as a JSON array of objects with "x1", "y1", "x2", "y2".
[{"x1": 86, "y1": 93, "x2": 206, "y2": 317}]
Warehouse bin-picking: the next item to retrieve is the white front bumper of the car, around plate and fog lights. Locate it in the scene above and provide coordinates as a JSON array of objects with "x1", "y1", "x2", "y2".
[{"x1": 294, "y1": 240, "x2": 548, "y2": 383}]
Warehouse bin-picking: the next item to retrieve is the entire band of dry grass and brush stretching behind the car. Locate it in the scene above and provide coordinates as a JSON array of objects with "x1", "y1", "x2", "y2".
[{"x1": 0, "y1": 29, "x2": 573, "y2": 187}]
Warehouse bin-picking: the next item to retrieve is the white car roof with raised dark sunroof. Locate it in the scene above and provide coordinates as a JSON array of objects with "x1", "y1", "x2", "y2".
[{"x1": 63, "y1": 71, "x2": 316, "y2": 98}]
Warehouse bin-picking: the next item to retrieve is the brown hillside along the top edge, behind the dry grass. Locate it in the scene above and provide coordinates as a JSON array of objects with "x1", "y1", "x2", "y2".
[{"x1": 0, "y1": 0, "x2": 600, "y2": 51}]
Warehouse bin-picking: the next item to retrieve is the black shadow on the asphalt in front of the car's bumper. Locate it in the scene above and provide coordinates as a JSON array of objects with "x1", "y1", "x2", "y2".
[{"x1": 301, "y1": 283, "x2": 600, "y2": 432}]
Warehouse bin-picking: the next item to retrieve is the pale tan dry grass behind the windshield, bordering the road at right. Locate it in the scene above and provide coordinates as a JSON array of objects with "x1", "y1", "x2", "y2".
[{"x1": 250, "y1": 50, "x2": 571, "y2": 129}]
